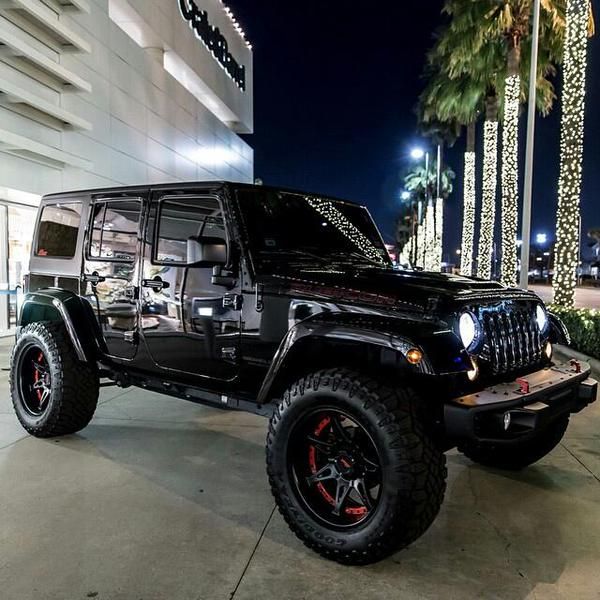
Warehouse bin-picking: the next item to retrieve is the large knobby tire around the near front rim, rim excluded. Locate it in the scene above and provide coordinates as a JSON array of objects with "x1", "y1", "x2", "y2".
[{"x1": 267, "y1": 369, "x2": 447, "y2": 565}]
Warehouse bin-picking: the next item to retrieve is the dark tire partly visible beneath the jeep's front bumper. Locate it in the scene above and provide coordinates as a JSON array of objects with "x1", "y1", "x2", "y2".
[{"x1": 459, "y1": 415, "x2": 569, "y2": 471}]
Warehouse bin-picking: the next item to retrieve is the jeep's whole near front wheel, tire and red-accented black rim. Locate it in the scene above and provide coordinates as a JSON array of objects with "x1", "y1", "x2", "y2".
[{"x1": 267, "y1": 370, "x2": 446, "y2": 565}]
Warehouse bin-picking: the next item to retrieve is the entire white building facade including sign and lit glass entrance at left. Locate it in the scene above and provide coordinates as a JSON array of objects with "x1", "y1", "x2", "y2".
[{"x1": 0, "y1": 0, "x2": 253, "y2": 332}]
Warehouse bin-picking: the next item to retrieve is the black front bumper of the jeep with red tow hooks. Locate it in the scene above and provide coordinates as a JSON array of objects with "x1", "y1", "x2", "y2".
[{"x1": 444, "y1": 362, "x2": 598, "y2": 444}]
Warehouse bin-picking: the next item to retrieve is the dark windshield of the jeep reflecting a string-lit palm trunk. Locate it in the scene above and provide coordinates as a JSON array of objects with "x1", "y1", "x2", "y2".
[{"x1": 238, "y1": 189, "x2": 391, "y2": 272}]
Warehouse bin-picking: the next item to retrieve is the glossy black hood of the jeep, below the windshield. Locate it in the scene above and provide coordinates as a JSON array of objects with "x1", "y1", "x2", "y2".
[{"x1": 259, "y1": 268, "x2": 538, "y2": 312}]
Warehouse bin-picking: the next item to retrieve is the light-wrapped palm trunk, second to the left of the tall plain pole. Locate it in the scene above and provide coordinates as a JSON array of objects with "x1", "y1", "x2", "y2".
[{"x1": 477, "y1": 92, "x2": 498, "y2": 279}]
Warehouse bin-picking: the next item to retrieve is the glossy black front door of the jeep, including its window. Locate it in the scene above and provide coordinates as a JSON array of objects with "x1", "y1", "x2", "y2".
[{"x1": 141, "y1": 195, "x2": 241, "y2": 381}]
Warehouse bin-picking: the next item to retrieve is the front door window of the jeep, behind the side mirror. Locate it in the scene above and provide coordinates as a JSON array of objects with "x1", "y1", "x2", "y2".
[{"x1": 154, "y1": 198, "x2": 227, "y2": 265}]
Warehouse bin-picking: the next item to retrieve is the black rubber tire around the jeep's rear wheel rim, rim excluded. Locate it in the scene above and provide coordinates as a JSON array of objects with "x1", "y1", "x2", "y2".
[{"x1": 10, "y1": 321, "x2": 99, "y2": 438}]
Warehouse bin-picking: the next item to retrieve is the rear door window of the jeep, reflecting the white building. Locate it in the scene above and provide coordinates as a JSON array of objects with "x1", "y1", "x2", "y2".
[{"x1": 89, "y1": 200, "x2": 142, "y2": 262}]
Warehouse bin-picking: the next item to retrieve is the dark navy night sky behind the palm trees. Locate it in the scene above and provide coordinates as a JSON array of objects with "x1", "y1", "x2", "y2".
[{"x1": 228, "y1": 0, "x2": 600, "y2": 259}]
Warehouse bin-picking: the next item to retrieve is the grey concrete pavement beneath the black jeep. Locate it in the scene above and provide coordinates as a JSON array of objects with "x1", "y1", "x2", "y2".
[{"x1": 0, "y1": 344, "x2": 600, "y2": 600}]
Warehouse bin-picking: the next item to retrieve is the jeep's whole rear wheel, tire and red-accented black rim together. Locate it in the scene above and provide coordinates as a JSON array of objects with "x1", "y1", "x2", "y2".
[{"x1": 10, "y1": 322, "x2": 99, "y2": 438}]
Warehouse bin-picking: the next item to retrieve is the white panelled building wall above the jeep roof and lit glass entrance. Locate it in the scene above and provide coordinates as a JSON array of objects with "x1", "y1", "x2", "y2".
[{"x1": 0, "y1": 0, "x2": 253, "y2": 194}]
